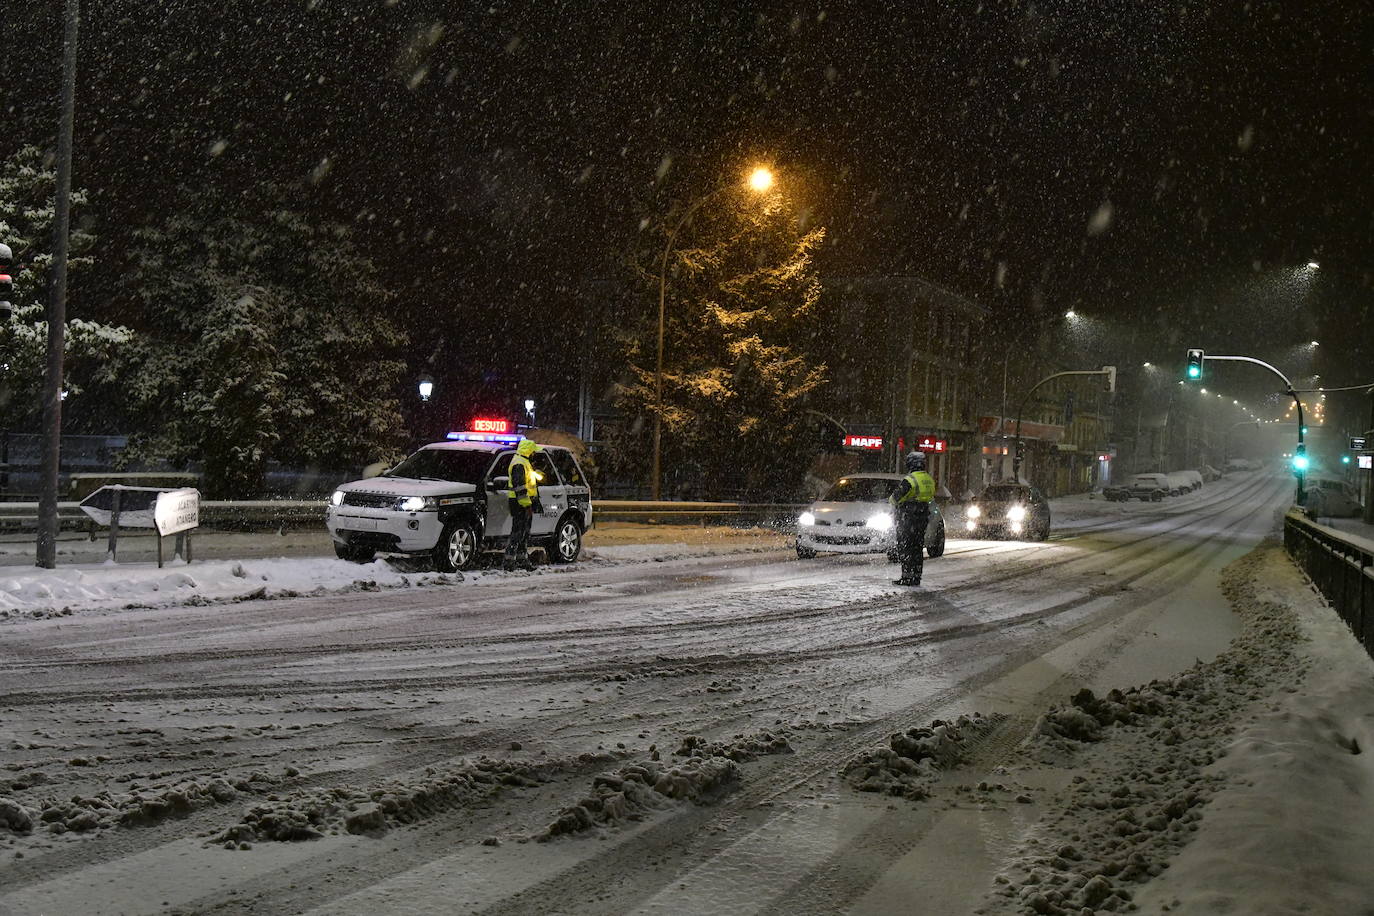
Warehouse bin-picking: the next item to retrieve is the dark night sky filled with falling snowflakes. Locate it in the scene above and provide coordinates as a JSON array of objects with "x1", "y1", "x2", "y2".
[{"x1": 0, "y1": 0, "x2": 1374, "y2": 431}]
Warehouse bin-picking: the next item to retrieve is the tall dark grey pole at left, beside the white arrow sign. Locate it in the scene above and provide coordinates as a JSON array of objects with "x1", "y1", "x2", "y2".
[{"x1": 36, "y1": 0, "x2": 81, "y2": 570}]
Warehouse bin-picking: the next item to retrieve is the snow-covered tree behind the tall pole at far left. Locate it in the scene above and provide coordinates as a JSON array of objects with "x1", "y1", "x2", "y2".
[{"x1": 0, "y1": 146, "x2": 129, "y2": 430}]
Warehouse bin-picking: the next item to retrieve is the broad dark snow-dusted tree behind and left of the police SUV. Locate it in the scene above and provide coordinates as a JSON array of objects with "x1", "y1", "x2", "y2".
[{"x1": 120, "y1": 201, "x2": 404, "y2": 496}]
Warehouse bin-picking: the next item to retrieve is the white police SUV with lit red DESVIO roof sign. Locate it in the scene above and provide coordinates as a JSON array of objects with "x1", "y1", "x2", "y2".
[{"x1": 332, "y1": 433, "x2": 592, "y2": 573}]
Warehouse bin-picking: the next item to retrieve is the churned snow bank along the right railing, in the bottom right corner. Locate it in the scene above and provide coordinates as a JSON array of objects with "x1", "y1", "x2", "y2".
[{"x1": 981, "y1": 547, "x2": 1374, "y2": 916}]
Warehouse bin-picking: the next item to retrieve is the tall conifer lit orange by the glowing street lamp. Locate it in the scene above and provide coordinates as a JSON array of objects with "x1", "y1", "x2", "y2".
[{"x1": 617, "y1": 189, "x2": 826, "y2": 494}]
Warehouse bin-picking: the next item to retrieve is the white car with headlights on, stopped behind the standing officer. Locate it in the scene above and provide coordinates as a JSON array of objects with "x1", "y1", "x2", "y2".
[{"x1": 797, "y1": 474, "x2": 945, "y2": 560}]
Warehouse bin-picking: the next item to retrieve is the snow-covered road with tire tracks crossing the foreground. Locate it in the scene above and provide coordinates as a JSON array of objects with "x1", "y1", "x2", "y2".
[{"x1": 0, "y1": 477, "x2": 1341, "y2": 913}]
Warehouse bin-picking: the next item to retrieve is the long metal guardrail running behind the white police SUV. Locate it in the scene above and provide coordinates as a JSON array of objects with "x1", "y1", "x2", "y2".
[{"x1": 0, "y1": 500, "x2": 807, "y2": 531}]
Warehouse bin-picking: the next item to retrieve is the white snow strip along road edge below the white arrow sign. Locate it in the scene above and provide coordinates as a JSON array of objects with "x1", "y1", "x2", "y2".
[{"x1": 0, "y1": 558, "x2": 463, "y2": 618}]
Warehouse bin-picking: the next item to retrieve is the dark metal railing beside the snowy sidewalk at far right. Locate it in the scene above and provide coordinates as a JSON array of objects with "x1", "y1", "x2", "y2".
[{"x1": 1283, "y1": 509, "x2": 1374, "y2": 656}]
